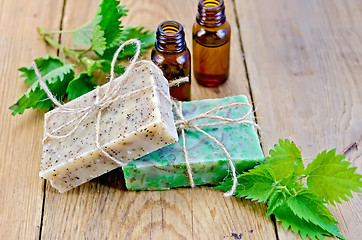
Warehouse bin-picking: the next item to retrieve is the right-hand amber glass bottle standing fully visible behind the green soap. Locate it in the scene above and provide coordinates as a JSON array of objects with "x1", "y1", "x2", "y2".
[{"x1": 192, "y1": 0, "x2": 231, "y2": 87}]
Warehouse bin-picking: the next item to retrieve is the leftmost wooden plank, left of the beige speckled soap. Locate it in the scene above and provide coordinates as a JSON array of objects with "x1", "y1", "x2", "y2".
[{"x1": 0, "y1": 0, "x2": 62, "y2": 239}]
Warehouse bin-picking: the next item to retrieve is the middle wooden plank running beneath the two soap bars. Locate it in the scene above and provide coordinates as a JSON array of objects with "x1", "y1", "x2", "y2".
[{"x1": 42, "y1": 0, "x2": 275, "y2": 239}]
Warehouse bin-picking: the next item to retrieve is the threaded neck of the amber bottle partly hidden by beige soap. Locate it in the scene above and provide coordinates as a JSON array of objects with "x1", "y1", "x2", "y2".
[{"x1": 155, "y1": 21, "x2": 186, "y2": 53}]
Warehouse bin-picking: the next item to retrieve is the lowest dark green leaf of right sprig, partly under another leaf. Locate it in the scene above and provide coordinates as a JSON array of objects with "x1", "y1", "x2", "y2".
[{"x1": 273, "y1": 203, "x2": 331, "y2": 240}]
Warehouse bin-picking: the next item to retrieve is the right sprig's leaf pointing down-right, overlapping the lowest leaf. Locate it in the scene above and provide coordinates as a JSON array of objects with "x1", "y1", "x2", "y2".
[{"x1": 286, "y1": 188, "x2": 344, "y2": 239}]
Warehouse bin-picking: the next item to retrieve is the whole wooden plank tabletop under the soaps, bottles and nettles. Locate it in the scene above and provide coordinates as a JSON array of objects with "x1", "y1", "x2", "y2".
[{"x1": 0, "y1": 0, "x2": 362, "y2": 240}]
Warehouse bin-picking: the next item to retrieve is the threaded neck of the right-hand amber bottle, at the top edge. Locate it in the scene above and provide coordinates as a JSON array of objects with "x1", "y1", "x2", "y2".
[{"x1": 196, "y1": 0, "x2": 226, "y2": 27}]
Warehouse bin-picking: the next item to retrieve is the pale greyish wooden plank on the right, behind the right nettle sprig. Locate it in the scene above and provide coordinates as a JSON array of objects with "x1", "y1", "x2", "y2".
[{"x1": 235, "y1": 0, "x2": 362, "y2": 239}]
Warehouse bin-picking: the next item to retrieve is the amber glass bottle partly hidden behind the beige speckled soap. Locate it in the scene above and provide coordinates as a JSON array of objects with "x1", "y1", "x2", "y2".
[{"x1": 151, "y1": 21, "x2": 191, "y2": 101}]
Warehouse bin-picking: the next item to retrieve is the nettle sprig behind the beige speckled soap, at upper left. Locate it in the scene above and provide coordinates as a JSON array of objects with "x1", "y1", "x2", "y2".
[{"x1": 10, "y1": 0, "x2": 155, "y2": 115}]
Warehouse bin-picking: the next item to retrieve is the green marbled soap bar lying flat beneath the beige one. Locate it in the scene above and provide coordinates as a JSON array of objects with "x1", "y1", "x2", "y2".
[{"x1": 123, "y1": 95, "x2": 264, "y2": 190}]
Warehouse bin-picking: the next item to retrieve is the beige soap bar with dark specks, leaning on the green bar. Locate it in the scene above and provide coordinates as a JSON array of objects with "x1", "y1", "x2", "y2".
[{"x1": 39, "y1": 63, "x2": 178, "y2": 192}]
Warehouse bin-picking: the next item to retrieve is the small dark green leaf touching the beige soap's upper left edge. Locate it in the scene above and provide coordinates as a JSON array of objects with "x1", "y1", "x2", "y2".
[{"x1": 67, "y1": 72, "x2": 97, "y2": 100}]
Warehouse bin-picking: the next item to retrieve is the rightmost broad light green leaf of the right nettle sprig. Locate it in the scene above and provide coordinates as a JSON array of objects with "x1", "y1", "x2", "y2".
[{"x1": 304, "y1": 149, "x2": 362, "y2": 205}]
